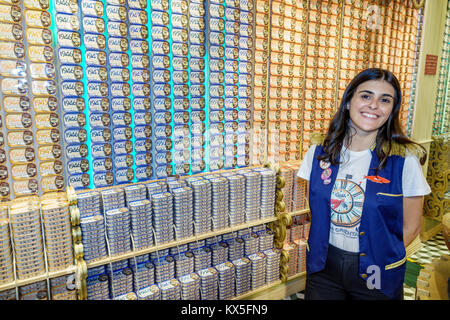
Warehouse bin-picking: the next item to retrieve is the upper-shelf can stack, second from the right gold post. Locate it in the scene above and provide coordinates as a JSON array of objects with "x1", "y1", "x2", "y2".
[{"x1": 242, "y1": 171, "x2": 261, "y2": 222}]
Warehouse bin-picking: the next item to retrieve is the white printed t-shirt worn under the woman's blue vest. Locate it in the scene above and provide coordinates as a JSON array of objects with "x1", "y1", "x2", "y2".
[{"x1": 297, "y1": 145, "x2": 431, "y2": 252}]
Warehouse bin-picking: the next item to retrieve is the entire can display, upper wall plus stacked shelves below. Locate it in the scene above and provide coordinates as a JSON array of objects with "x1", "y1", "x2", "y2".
[{"x1": 0, "y1": 0, "x2": 432, "y2": 299}]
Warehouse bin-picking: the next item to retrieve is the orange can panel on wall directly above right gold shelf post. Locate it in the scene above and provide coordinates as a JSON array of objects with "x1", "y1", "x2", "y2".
[{"x1": 267, "y1": 1, "x2": 307, "y2": 162}]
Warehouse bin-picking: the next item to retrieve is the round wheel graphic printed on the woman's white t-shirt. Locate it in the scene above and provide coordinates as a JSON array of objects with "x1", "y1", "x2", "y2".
[{"x1": 330, "y1": 179, "x2": 364, "y2": 228}]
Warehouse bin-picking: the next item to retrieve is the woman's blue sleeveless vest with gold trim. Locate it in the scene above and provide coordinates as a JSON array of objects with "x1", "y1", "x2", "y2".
[{"x1": 306, "y1": 145, "x2": 406, "y2": 298}]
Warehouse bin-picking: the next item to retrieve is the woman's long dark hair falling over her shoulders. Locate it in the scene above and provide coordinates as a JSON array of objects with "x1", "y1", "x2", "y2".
[{"x1": 318, "y1": 68, "x2": 426, "y2": 172}]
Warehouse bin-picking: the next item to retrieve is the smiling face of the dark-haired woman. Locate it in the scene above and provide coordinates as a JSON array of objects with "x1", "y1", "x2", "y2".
[{"x1": 349, "y1": 80, "x2": 395, "y2": 135}]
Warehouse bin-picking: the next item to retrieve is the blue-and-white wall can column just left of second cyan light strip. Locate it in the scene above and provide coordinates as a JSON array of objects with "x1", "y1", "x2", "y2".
[{"x1": 81, "y1": 1, "x2": 115, "y2": 188}]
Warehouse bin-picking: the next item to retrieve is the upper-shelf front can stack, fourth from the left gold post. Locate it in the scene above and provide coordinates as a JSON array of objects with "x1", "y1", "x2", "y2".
[{"x1": 151, "y1": 192, "x2": 174, "y2": 245}]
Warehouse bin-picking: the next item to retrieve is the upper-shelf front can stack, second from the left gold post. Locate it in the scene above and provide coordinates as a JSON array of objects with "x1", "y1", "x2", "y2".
[{"x1": 105, "y1": 208, "x2": 131, "y2": 255}]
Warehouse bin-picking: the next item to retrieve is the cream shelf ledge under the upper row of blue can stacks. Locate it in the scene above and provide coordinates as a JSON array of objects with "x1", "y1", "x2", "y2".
[{"x1": 87, "y1": 216, "x2": 278, "y2": 268}]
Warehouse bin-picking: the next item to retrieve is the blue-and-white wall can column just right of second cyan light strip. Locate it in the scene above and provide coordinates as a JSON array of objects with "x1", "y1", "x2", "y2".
[{"x1": 105, "y1": 0, "x2": 135, "y2": 184}]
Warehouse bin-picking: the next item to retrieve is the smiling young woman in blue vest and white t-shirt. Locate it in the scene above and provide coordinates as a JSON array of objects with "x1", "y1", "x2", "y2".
[{"x1": 297, "y1": 68, "x2": 431, "y2": 299}]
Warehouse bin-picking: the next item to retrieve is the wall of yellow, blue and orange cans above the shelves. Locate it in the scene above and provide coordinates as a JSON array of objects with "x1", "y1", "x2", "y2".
[{"x1": 0, "y1": 0, "x2": 421, "y2": 199}]
